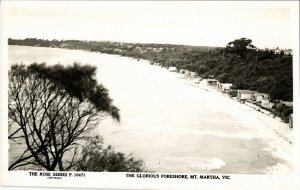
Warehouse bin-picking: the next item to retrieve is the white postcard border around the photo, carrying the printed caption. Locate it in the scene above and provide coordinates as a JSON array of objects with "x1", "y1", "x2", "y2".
[{"x1": 0, "y1": 2, "x2": 300, "y2": 189}]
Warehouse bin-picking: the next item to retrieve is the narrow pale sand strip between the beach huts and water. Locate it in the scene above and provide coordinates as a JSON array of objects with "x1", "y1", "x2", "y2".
[{"x1": 149, "y1": 63, "x2": 293, "y2": 174}]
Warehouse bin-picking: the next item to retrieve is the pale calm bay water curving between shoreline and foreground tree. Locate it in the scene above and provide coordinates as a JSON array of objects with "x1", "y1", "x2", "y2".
[{"x1": 9, "y1": 46, "x2": 291, "y2": 174}]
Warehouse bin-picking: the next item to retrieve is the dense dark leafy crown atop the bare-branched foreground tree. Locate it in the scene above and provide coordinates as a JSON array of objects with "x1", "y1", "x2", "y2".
[{"x1": 28, "y1": 63, "x2": 120, "y2": 120}]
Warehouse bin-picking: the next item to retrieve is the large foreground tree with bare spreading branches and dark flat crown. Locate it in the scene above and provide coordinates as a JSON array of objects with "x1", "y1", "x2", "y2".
[{"x1": 8, "y1": 64, "x2": 120, "y2": 171}]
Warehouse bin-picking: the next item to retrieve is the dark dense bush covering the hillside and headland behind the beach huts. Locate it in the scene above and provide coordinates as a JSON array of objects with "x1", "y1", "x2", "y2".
[{"x1": 8, "y1": 38, "x2": 293, "y2": 101}]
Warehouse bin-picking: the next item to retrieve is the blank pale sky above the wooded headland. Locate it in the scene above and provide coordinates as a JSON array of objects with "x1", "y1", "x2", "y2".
[{"x1": 5, "y1": 1, "x2": 297, "y2": 49}]
